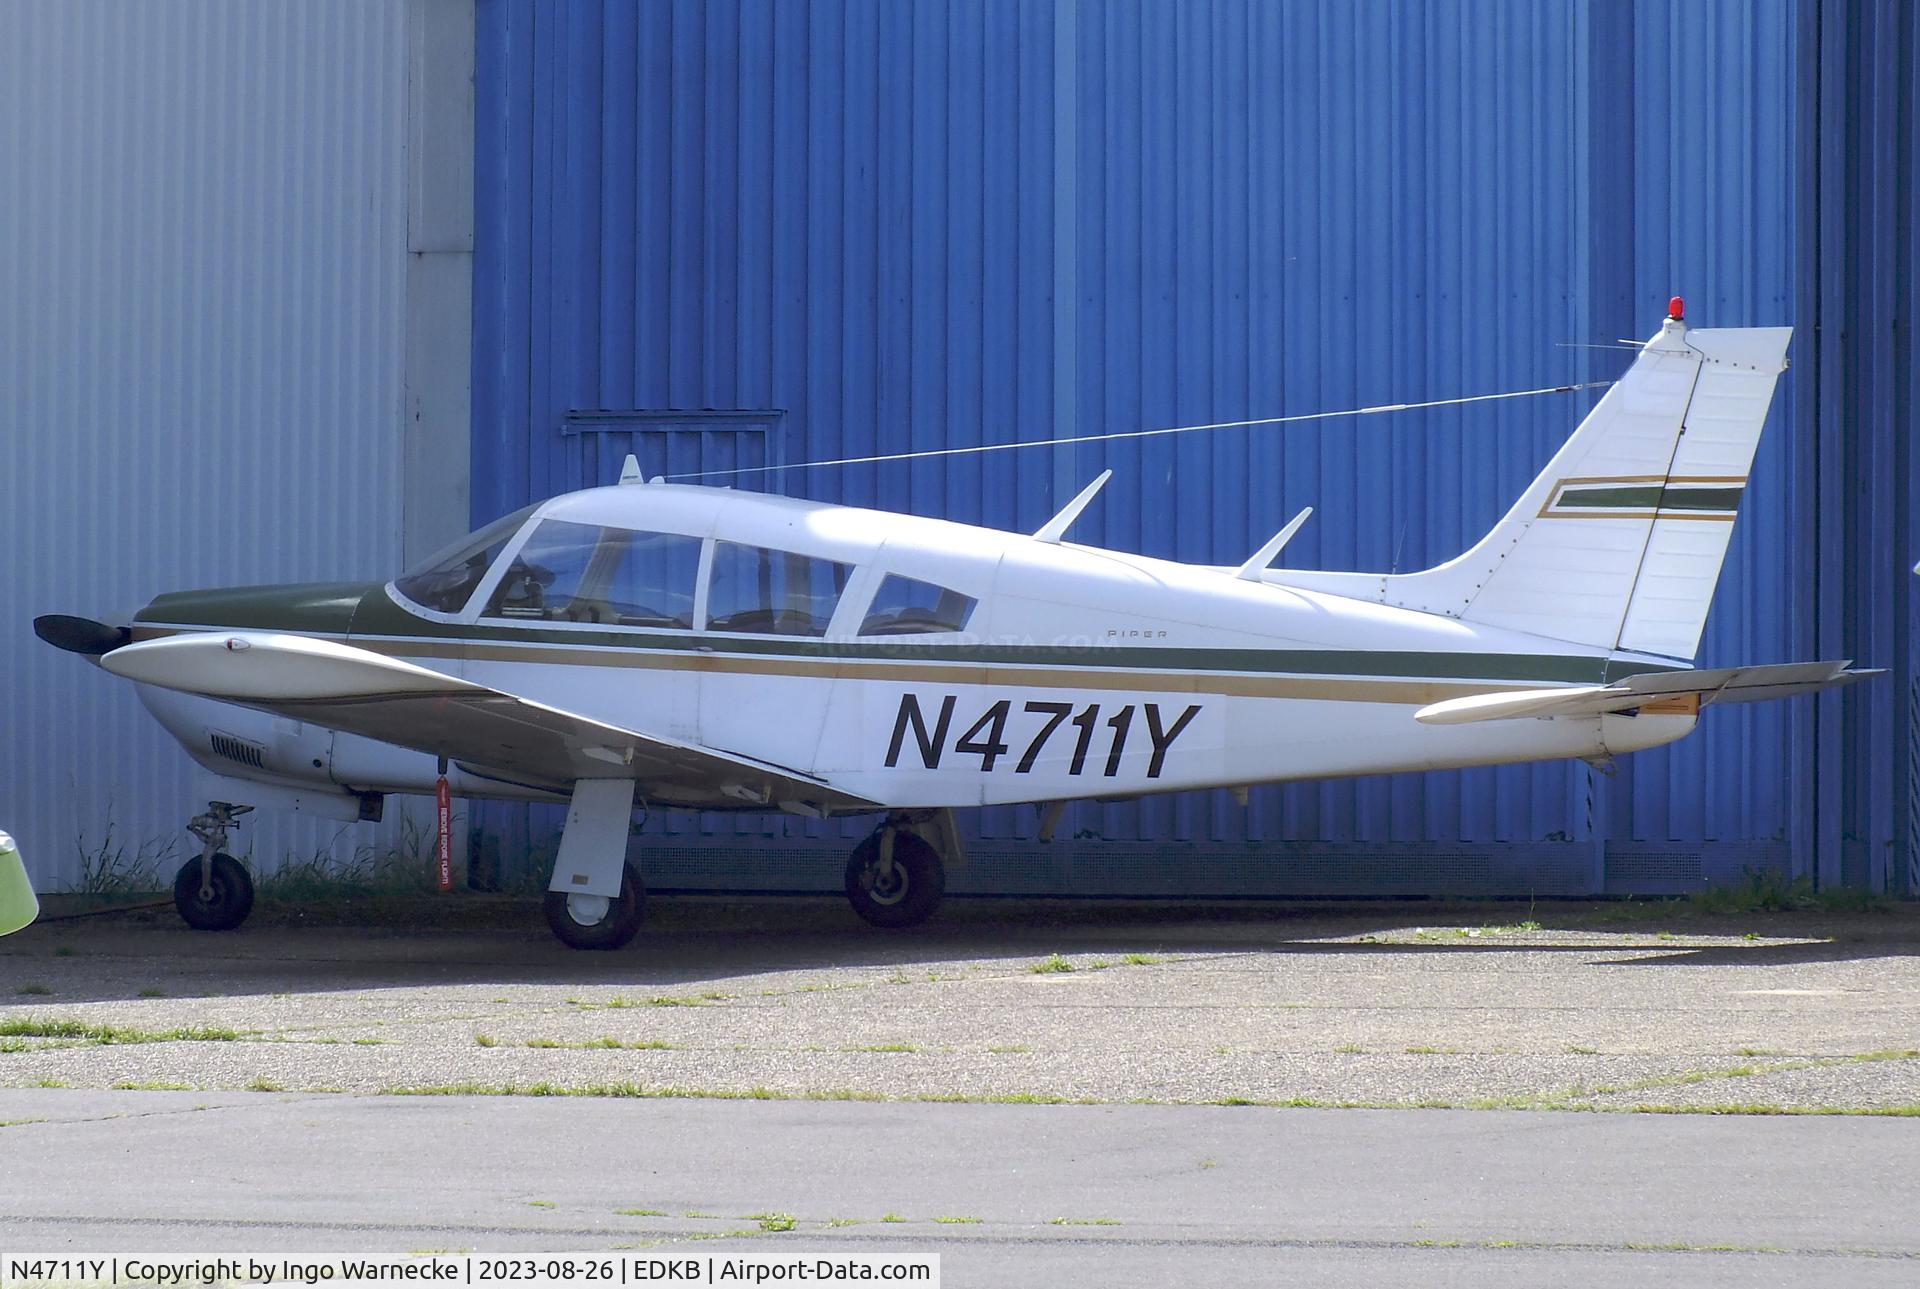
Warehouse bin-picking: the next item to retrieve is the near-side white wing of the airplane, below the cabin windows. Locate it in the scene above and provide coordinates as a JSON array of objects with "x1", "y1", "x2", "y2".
[{"x1": 100, "y1": 632, "x2": 876, "y2": 811}]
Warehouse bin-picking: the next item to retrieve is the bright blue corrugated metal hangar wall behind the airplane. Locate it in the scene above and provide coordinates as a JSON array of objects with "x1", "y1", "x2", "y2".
[{"x1": 472, "y1": 0, "x2": 1916, "y2": 893}]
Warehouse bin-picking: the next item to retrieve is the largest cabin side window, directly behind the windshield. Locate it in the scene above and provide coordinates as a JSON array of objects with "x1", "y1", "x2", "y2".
[{"x1": 486, "y1": 519, "x2": 701, "y2": 630}]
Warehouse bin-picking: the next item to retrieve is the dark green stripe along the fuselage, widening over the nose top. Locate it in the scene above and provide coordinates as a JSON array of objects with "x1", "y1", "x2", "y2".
[{"x1": 136, "y1": 582, "x2": 1684, "y2": 684}]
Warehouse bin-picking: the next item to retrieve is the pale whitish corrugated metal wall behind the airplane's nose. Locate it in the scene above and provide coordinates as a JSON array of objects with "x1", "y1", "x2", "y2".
[{"x1": 0, "y1": 0, "x2": 407, "y2": 888}]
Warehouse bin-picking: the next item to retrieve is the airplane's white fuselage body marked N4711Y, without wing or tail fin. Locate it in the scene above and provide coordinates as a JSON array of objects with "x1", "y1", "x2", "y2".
[{"x1": 134, "y1": 484, "x2": 1693, "y2": 807}]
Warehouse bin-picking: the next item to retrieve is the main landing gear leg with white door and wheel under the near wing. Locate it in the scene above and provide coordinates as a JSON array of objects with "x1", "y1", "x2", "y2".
[{"x1": 545, "y1": 778, "x2": 647, "y2": 949}]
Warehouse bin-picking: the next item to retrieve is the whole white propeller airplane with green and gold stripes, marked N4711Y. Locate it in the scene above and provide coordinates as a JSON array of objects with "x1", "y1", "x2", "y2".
[{"x1": 36, "y1": 302, "x2": 1868, "y2": 949}]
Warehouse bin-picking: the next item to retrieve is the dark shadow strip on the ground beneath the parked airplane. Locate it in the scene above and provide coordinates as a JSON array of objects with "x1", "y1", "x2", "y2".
[{"x1": 0, "y1": 897, "x2": 1920, "y2": 1016}]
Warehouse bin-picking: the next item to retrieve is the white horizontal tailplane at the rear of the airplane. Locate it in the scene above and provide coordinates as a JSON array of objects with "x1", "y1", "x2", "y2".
[{"x1": 1413, "y1": 663, "x2": 1882, "y2": 724}]
